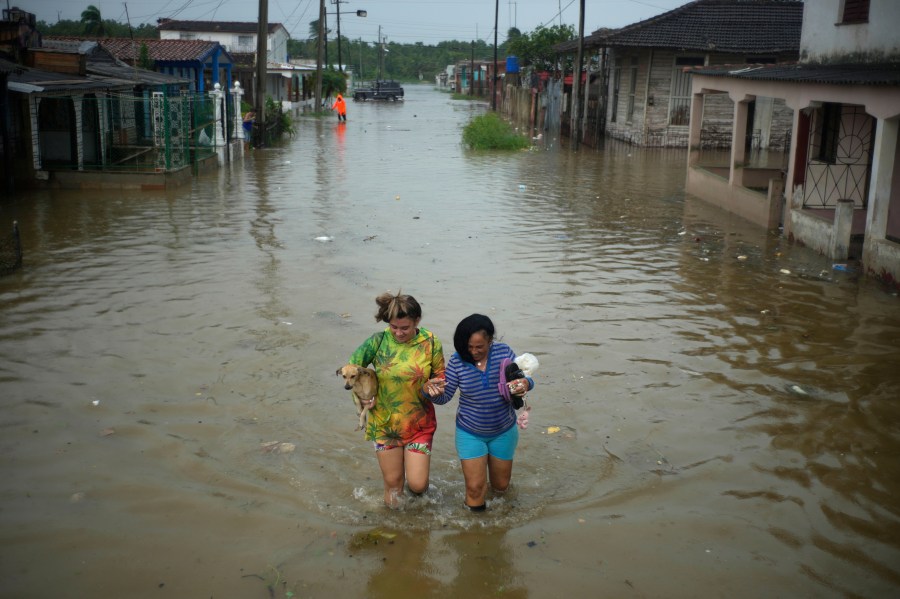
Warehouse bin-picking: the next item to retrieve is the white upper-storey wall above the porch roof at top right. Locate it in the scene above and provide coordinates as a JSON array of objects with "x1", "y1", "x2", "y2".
[{"x1": 800, "y1": 0, "x2": 900, "y2": 63}]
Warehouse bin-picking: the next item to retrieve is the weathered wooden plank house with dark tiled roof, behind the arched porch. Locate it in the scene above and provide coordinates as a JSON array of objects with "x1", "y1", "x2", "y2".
[{"x1": 556, "y1": 0, "x2": 803, "y2": 148}]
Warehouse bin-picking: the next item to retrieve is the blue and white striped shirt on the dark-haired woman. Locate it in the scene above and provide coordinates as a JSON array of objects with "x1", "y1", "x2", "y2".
[{"x1": 432, "y1": 342, "x2": 534, "y2": 437}]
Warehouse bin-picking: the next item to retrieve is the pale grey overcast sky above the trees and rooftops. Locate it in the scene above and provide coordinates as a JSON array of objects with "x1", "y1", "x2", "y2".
[{"x1": 26, "y1": 0, "x2": 689, "y2": 45}]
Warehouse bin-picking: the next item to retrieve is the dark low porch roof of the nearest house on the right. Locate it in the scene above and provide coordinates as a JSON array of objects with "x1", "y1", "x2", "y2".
[{"x1": 691, "y1": 63, "x2": 900, "y2": 86}]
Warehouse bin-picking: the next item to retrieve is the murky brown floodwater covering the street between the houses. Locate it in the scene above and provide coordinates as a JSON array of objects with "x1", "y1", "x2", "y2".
[{"x1": 0, "y1": 86, "x2": 900, "y2": 598}]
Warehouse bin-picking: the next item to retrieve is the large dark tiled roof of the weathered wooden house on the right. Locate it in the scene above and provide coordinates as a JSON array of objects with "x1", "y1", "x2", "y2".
[{"x1": 556, "y1": 0, "x2": 803, "y2": 55}]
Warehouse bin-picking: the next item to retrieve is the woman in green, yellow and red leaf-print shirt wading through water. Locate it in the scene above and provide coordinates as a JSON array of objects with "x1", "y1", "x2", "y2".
[{"x1": 350, "y1": 293, "x2": 444, "y2": 508}]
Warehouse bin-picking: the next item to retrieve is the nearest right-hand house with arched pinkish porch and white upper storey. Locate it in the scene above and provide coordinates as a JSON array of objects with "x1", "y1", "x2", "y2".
[{"x1": 687, "y1": 0, "x2": 900, "y2": 285}]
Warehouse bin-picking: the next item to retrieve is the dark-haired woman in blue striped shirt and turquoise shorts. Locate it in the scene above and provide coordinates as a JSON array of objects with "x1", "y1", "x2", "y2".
[{"x1": 425, "y1": 314, "x2": 534, "y2": 511}]
